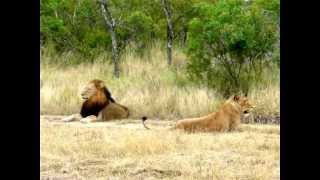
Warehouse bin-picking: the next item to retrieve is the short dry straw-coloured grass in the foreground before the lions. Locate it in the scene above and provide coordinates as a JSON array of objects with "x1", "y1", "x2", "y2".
[{"x1": 40, "y1": 116, "x2": 280, "y2": 180}]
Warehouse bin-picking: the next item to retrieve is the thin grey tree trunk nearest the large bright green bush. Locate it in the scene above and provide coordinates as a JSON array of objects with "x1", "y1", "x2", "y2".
[{"x1": 161, "y1": 0, "x2": 173, "y2": 65}]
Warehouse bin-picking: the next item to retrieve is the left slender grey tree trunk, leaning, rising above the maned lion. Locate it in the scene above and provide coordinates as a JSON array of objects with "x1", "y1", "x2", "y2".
[{"x1": 99, "y1": 0, "x2": 120, "y2": 78}]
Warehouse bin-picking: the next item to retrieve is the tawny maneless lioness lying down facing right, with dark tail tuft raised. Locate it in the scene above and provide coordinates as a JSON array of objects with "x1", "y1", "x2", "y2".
[{"x1": 142, "y1": 95, "x2": 253, "y2": 132}]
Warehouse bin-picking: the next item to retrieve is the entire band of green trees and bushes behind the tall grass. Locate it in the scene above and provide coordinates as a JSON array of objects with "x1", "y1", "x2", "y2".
[{"x1": 40, "y1": 0, "x2": 280, "y2": 95}]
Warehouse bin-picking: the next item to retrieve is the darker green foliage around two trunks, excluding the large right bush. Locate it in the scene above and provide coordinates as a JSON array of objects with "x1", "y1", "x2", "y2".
[{"x1": 40, "y1": 0, "x2": 210, "y2": 59}]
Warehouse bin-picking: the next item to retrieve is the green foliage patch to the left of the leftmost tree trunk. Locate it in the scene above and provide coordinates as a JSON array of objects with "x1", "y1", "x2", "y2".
[{"x1": 40, "y1": 0, "x2": 109, "y2": 59}]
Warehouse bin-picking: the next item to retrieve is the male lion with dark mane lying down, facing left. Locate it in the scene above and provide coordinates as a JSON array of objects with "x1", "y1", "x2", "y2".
[{"x1": 62, "y1": 79, "x2": 129, "y2": 123}]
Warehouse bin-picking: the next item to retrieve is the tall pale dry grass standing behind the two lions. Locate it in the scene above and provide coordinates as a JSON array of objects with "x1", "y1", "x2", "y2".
[{"x1": 40, "y1": 46, "x2": 280, "y2": 119}]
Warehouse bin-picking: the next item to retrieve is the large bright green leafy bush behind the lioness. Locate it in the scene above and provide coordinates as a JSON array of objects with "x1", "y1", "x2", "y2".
[{"x1": 187, "y1": 0, "x2": 278, "y2": 95}]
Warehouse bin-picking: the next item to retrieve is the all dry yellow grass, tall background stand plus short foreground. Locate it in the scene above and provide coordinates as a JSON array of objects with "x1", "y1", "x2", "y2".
[{"x1": 40, "y1": 44, "x2": 280, "y2": 180}]
